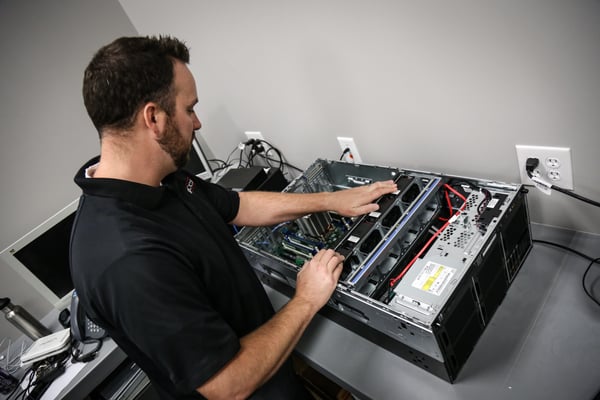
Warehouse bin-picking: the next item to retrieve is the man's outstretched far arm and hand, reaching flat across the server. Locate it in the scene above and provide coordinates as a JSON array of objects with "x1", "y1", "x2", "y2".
[{"x1": 232, "y1": 181, "x2": 398, "y2": 226}]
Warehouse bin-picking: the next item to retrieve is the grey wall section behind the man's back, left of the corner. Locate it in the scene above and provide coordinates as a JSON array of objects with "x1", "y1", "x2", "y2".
[{"x1": 0, "y1": 0, "x2": 137, "y2": 340}]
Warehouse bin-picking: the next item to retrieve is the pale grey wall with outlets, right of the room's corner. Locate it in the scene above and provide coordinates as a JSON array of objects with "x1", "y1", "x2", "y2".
[{"x1": 120, "y1": 0, "x2": 600, "y2": 233}]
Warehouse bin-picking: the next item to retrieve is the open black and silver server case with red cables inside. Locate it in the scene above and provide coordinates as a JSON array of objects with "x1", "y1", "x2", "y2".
[{"x1": 236, "y1": 159, "x2": 532, "y2": 382}]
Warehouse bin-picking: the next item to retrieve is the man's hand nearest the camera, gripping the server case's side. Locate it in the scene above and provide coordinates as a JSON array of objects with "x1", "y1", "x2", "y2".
[{"x1": 295, "y1": 249, "x2": 344, "y2": 313}]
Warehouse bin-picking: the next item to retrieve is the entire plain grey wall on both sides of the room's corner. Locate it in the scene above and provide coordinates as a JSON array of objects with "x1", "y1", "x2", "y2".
[{"x1": 0, "y1": 0, "x2": 600, "y2": 338}]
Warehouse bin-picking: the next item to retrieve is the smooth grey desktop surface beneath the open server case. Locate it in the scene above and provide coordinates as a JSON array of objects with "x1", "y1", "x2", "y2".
[{"x1": 269, "y1": 225, "x2": 600, "y2": 400}]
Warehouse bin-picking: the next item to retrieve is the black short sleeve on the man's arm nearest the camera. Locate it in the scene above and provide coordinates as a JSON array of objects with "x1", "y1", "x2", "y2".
[{"x1": 97, "y1": 249, "x2": 240, "y2": 392}]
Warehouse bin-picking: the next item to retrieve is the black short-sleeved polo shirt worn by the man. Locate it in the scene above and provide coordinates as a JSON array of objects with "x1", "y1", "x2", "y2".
[{"x1": 71, "y1": 158, "x2": 306, "y2": 399}]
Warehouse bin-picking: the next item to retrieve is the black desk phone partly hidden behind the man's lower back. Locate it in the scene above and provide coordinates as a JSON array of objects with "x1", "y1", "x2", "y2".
[{"x1": 71, "y1": 290, "x2": 107, "y2": 362}]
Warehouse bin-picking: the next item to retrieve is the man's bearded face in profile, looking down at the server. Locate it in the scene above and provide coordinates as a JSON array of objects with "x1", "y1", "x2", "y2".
[{"x1": 158, "y1": 61, "x2": 202, "y2": 168}]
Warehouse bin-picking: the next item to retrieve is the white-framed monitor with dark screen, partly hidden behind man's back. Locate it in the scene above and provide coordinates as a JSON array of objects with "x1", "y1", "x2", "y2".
[{"x1": 0, "y1": 199, "x2": 79, "y2": 310}]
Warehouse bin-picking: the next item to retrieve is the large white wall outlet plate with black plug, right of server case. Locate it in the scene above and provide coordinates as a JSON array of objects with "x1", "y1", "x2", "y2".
[{"x1": 515, "y1": 144, "x2": 573, "y2": 190}]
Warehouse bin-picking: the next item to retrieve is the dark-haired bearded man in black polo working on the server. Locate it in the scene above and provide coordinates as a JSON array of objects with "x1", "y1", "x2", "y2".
[{"x1": 71, "y1": 37, "x2": 396, "y2": 399}]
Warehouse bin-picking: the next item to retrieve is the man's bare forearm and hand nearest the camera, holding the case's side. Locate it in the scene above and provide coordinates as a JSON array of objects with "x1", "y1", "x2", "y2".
[{"x1": 197, "y1": 250, "x2": 344, "y2": 399}]
